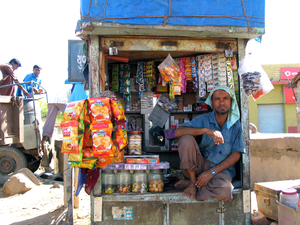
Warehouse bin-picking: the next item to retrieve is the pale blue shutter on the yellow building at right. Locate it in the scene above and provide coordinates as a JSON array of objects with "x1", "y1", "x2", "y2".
[{"x1": 257, "y1": 104, "x2": 284, "y2": 133}]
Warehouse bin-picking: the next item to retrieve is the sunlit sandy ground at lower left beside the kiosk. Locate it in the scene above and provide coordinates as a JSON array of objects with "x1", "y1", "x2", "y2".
[{"x1": 0, "y1": 178, "x2": 90, "y2": 225}]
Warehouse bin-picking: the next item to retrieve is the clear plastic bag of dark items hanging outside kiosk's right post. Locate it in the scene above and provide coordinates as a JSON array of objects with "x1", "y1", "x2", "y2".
[{"x1": 238, "y1": 54, "x2": 274, "y2": 100}]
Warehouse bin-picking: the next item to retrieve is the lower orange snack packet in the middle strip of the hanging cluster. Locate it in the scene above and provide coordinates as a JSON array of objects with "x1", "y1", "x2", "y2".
[{"x1": 91, "y1": 123, "x2": 113, "y2": 157}]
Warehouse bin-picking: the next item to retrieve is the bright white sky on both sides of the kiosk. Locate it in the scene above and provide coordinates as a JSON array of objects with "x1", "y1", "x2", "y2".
[{"x1": 0, "y1": 0, "x2": 300, "y2": 91}]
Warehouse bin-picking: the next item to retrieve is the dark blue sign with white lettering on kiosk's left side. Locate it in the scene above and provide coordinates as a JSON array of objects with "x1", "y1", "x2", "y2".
[{"x1": 68, "y1": 40, "x2": 86, "y2": 82}]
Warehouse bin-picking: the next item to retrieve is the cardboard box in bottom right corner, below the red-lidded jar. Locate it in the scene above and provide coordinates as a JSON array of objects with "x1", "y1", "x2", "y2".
[{"x1": 277, "y1": 202, "x2": 300, "y2": 225}]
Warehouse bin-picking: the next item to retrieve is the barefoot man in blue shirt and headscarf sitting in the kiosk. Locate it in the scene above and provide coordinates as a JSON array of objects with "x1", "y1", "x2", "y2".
[{"x1": 175, "y1": 86, "x2": 245, "y2": 201}]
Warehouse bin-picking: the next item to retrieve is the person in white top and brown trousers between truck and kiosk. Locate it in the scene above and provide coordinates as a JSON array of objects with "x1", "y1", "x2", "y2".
[{"x1": 42, "y1": 80, "x2": 72, "y2": 142}]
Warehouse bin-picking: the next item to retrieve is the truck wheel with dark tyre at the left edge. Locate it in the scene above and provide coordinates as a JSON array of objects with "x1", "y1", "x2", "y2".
[{"x1": 0, "y1": 146, "x2": 27, "y2": 184}]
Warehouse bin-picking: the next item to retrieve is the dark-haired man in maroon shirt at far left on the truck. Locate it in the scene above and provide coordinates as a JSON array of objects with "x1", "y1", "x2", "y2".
[{"x1": 0, "y1": 58, "x2": 28, "y2": 96}]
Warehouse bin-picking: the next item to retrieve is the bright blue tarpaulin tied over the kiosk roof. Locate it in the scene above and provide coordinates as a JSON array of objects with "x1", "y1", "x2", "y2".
[{"x1": 80, "y1": 0, "x2": 265, "y2": 28}]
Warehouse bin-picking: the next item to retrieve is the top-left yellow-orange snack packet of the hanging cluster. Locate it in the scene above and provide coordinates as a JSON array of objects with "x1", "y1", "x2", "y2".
[{"x1": 62, "y1": 100, "x2": 85, "y2": 123}]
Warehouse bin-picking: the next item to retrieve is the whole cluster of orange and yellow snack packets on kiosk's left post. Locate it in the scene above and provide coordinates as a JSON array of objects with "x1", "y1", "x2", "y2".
[{"x1": 61, "y1": 93, "x2": 128, "y2": 169}]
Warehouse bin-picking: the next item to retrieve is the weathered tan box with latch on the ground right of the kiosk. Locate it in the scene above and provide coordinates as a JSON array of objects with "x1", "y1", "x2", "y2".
[{"x1": 254, "y1": 179, "x2": 300, "y2": 221}]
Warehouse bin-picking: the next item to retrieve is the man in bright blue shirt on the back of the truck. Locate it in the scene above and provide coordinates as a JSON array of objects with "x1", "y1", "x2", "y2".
[{"x1": 17, "y1": 65, "x2": 43, "y2": 98}]
